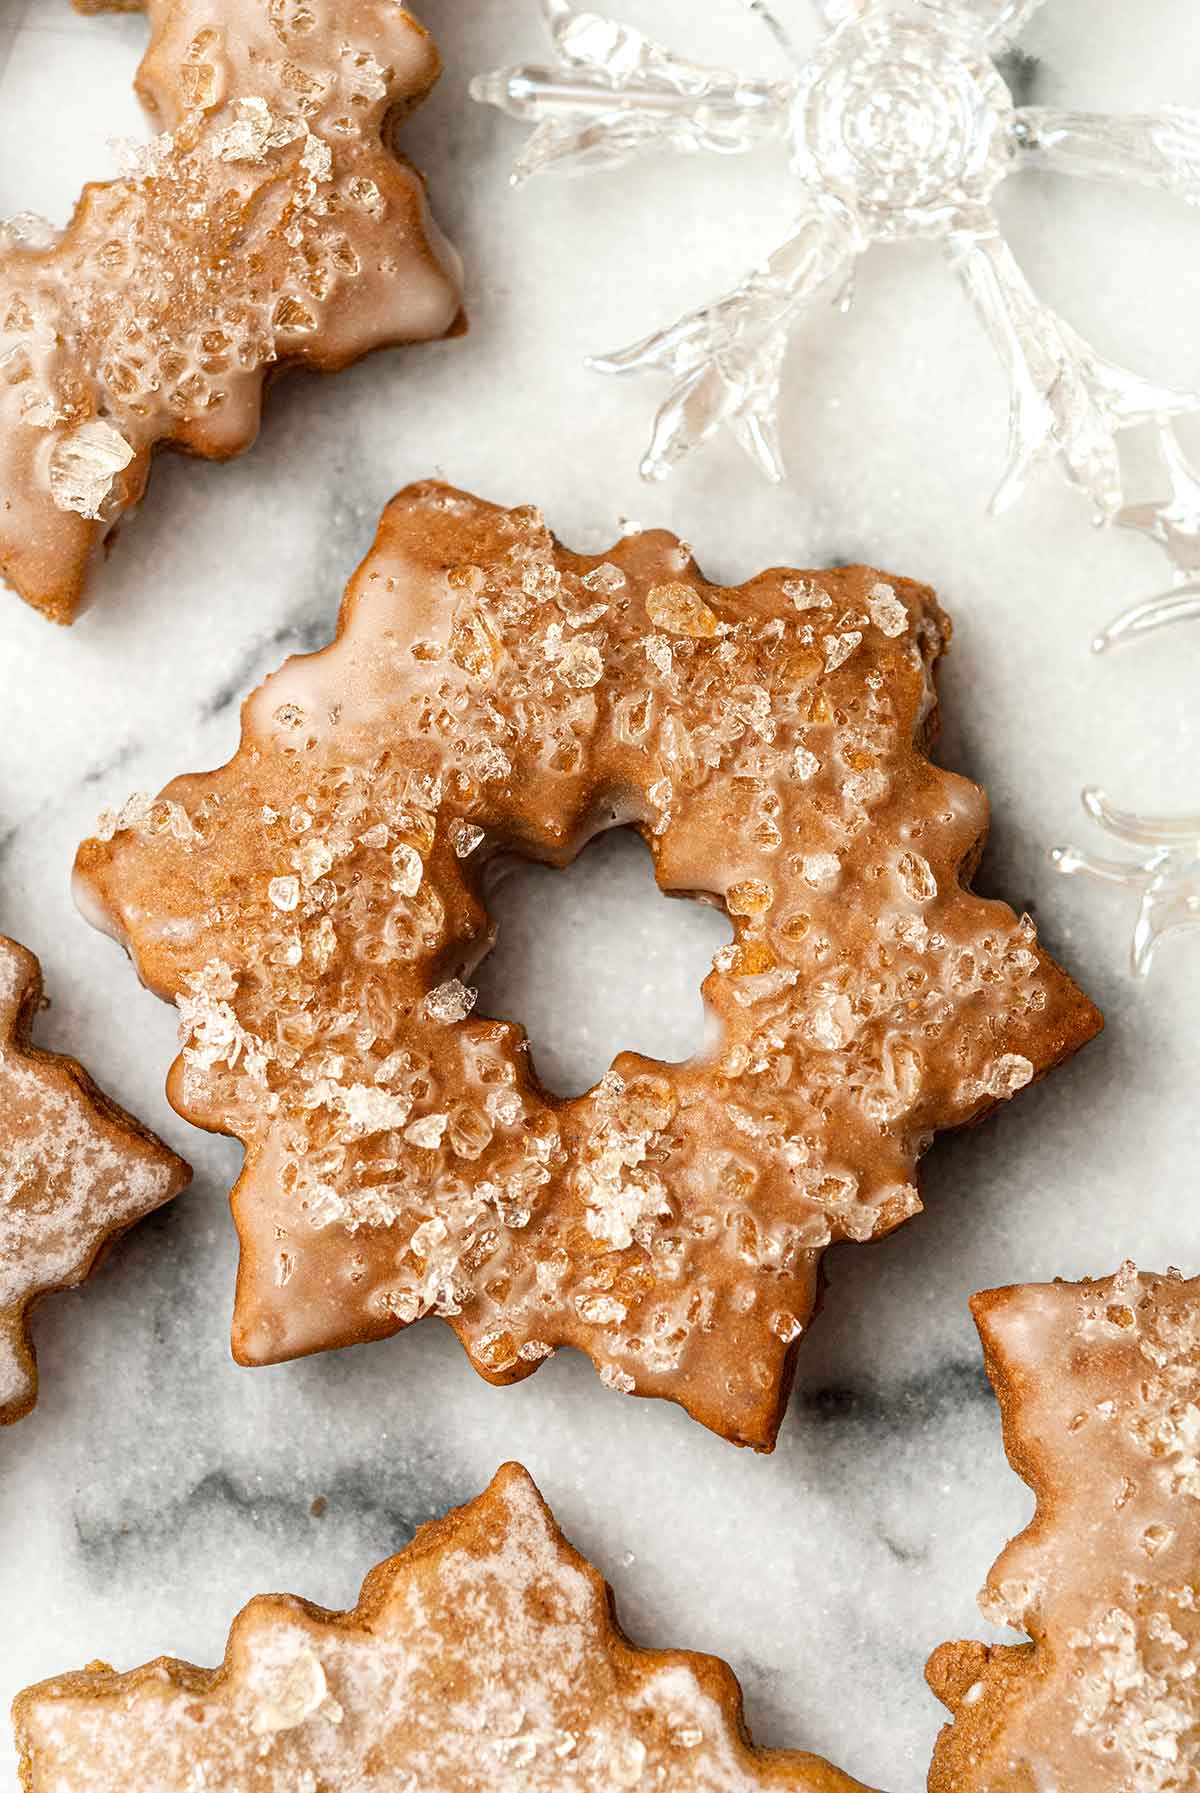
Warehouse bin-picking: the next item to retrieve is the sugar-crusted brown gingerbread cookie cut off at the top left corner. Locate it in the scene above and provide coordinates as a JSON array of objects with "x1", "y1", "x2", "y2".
[{"x1": 0, "y1": 0, "x2": 459, "y2": 622}]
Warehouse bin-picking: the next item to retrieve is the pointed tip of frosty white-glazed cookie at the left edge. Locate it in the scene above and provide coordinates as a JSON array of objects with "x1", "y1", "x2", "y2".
[{"x1": 0, "y1": 936, "x2": 192, "y2": 1425}]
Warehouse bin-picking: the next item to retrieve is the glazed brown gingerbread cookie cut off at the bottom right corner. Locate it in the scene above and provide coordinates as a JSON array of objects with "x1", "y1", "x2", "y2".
[{"x1": 926, "y1": 1264, "x2": 1200, "y2": 1793}]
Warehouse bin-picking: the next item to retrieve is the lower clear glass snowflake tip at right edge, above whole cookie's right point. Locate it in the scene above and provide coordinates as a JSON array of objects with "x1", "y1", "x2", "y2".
[{"x1": 1049, "y1": 787, "x2": 1200, "y2": 977}]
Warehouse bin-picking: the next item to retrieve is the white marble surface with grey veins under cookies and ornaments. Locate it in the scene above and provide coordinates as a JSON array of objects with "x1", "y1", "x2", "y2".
[{"x1": 0, "y1": 0, "x2": 1200, "y2": 1793}]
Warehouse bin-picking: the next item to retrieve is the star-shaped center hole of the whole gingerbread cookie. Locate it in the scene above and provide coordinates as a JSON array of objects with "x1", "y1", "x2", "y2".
[{"x1": 472, "y1": 828, "x2": 732, "y2": 1096}]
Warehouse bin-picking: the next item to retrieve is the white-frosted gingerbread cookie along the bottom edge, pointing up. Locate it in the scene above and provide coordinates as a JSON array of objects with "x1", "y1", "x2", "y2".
[{"x1": 14, "y1": 1463, "x2": 865, "y2": 1793}]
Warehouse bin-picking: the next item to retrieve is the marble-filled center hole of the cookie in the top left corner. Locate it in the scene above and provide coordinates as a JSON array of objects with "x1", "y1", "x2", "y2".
[{"x1": 0, "y1": 0, "x2": 154, "y2": 228}]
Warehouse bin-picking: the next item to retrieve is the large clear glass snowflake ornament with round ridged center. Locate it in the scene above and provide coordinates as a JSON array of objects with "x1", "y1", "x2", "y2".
[{"x1": 472, "y1": 0, "x2": 1200, "y2": 520}]
